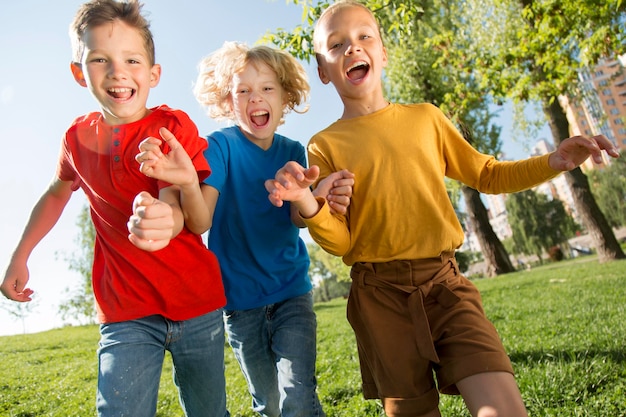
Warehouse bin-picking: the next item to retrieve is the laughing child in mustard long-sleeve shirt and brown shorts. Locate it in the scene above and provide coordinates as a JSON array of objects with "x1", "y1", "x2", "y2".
[{"x1": 266, "y1": 0, "x2": 618, "y2": 417}]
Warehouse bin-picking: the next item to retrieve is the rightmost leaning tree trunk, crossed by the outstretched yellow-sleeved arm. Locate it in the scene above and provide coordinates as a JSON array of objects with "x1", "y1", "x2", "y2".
[{"x1": 543, "y1": 99, "x2": 626, "y2": 262}]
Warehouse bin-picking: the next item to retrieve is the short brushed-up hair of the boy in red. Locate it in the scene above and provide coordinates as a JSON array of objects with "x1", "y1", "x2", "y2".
[{"x1": 70, "y1": 0, "x2": 155, "y2": 65}]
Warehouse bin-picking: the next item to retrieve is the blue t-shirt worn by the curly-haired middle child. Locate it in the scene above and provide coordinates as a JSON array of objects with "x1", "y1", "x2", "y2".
[{"x1": 204, "y1": 126, "x2": 312, "y2": 310}]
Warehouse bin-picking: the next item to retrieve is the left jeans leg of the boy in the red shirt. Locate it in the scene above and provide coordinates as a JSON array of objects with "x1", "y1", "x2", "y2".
[{"x1": 96, "y1": 316, "x2": 167, "y2": 417}]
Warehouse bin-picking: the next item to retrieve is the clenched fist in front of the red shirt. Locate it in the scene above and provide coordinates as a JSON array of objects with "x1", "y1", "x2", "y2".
[{"x1": 127, "y1": 191, "x2": 175, "y2": 252}]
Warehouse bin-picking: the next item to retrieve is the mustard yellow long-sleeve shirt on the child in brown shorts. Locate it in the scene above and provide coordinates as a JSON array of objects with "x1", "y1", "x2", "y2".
[{"x1": 305, "y1": 104, "x2": 559, "y2": 265}]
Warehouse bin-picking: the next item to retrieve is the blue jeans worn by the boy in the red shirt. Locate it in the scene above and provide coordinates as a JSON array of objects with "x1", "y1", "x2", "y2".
[{"x1": 96, "y1": 309, "x2": 230, "y2": 417}]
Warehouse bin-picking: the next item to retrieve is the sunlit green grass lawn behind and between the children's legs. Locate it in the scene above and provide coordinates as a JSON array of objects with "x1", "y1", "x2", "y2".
[{"x1": 0, "y1": 257, "x2": 626, "y2": 417}]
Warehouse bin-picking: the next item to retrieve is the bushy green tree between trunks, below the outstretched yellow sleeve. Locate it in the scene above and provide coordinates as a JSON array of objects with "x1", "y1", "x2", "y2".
[{"x1": 506, "y1": 190, "x2": 576, "y2": 261}]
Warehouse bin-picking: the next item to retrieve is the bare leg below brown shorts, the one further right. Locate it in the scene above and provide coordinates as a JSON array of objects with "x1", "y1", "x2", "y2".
[{"x1": 456, "y1": 372, "x2": 528, "y2": 417}]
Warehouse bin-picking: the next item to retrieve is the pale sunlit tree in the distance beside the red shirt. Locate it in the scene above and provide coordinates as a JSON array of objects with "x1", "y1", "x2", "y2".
[{"x1": 59, "y1": 205, "x2": 96, "y2": 324}]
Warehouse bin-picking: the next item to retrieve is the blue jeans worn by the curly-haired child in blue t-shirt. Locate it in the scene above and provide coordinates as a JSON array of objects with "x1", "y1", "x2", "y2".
[{"x1": 224, "y1": 293, "x2": 325, "y2": 417}]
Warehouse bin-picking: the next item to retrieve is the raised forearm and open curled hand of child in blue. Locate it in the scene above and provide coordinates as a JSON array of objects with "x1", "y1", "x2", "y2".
[{"x1": 135, "y1": 128, "x2": 212, "y2": 234}]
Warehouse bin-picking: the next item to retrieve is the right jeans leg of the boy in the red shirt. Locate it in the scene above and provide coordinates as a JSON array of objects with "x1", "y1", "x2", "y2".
[{"x1": 166, "y1": 309, "x2": 229, "y2": 417}]
